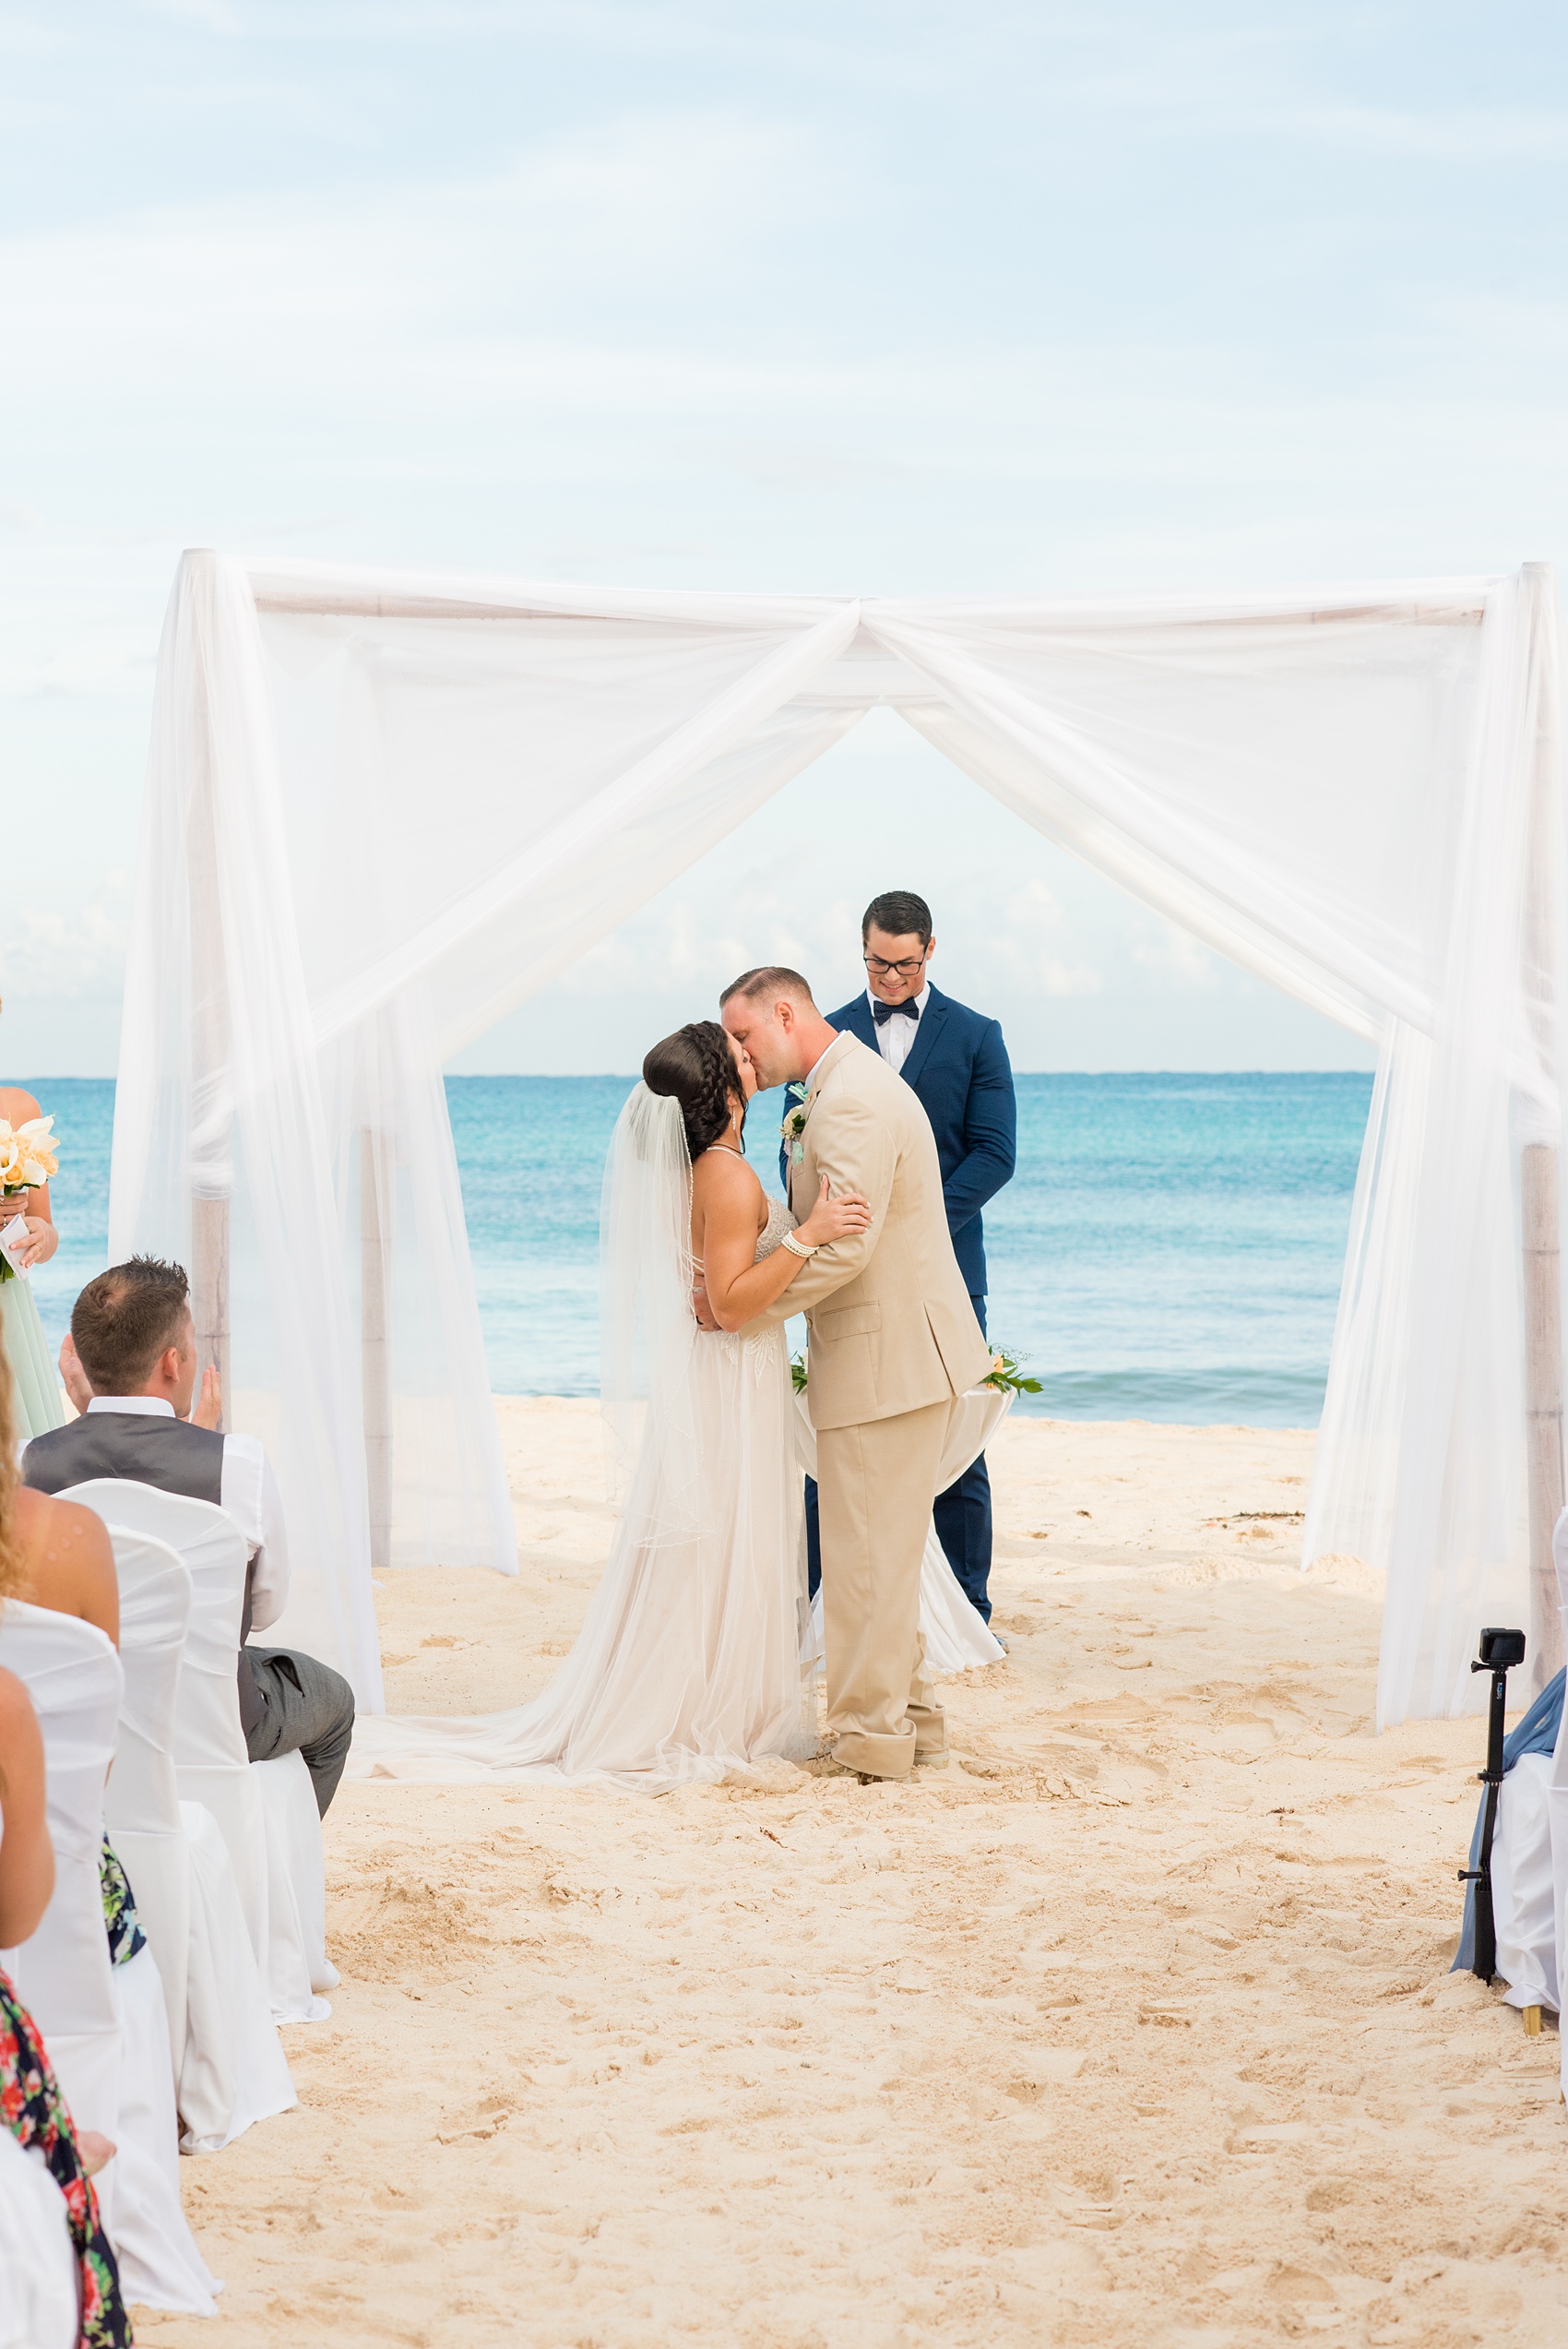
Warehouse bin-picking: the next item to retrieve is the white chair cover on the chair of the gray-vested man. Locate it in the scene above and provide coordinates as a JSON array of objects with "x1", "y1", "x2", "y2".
[{"x1": 61, "y1": 1477, "x2": 331, "y2": 2022}]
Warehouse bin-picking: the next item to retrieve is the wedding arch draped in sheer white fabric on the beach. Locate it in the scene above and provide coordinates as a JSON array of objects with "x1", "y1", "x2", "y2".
[{"x1": 111, "y1": 552, "x2": 1561, "y2": 1722}]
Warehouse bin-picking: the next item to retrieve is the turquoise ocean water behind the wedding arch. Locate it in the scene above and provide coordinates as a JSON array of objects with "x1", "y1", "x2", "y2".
[{"x1": 26, "y1": 1074, "x2": 1371, "y2": 1425}]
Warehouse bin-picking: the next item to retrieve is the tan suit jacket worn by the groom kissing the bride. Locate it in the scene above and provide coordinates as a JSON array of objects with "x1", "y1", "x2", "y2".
[{"x1": 755, "y1": 1036, "x2": 991, "y2": 1428}]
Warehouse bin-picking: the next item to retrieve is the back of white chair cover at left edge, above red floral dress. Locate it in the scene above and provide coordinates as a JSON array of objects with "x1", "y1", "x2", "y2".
[{"x1": 0, "y1": 1600, "x2": 120, "y2": 2241}]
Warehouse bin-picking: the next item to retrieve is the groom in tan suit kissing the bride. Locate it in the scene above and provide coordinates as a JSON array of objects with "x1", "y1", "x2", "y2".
[{"x1": 719, "y1": 968, "x2": 991, "y2": 1778}]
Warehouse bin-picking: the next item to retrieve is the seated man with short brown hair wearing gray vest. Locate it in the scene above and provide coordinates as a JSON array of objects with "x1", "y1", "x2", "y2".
[{"x1": 21, "y1": 1257, "x2": 354, "y2": 1814}]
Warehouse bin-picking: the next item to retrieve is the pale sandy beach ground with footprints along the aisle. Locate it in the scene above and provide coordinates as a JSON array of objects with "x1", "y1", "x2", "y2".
[{"x1": 138, "y1": 1402, "x2": 1568, "y2": 2349}]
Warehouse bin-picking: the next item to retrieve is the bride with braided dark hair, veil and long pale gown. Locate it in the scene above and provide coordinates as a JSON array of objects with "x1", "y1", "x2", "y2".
[{"x1": 350, "y1": 1019, "x2": 871, "y2": 1793}]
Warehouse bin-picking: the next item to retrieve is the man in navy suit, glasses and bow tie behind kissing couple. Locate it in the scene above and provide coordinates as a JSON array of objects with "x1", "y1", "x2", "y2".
[{"x1": 784, "y1": 888, "x2": 1018, "y2": 1621}]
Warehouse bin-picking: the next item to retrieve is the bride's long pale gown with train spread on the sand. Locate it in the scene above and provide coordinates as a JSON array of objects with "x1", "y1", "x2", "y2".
[{"x1": 348, "y1": 1200, "x2": 814, "y2": 1793}]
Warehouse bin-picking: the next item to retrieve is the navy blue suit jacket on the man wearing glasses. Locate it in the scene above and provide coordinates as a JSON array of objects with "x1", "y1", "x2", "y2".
[{"x1": 784, "y1": 986, "x2": 1018, "y2": 1296}]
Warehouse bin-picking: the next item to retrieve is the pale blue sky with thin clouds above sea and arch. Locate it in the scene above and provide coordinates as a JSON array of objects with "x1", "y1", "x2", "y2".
[{"x1": 0, "y1": 0, "x2": 1568, "y2": 1074}]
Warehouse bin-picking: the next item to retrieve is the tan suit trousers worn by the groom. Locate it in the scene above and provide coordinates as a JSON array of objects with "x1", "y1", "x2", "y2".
[{"x1": 817, "y1": 1402, "x2": 953, "y2": 1778}]
